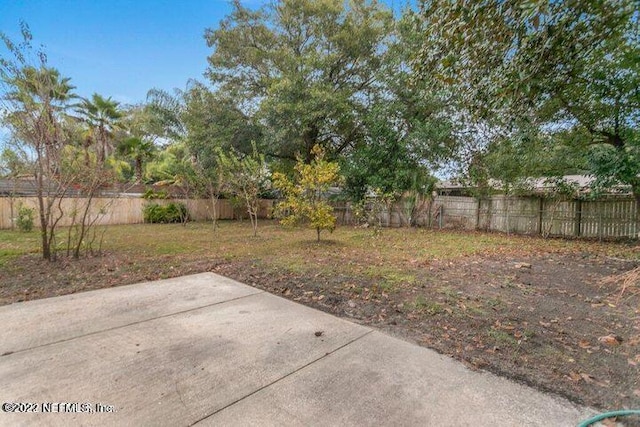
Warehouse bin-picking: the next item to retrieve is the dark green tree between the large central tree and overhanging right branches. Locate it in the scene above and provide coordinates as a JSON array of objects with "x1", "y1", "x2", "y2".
[{"x1": 342, "y1": 10, "x2": 459, "y2": 201}]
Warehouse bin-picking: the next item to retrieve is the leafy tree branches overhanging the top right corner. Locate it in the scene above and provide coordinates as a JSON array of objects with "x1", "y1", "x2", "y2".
[{"x1": 414, "y1": 0, "x2": 640, "y2": 201}]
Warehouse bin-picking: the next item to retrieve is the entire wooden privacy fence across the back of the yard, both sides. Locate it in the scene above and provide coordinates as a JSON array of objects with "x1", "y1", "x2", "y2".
[{"x1": 0, "y1": 196, "x2": 640, "y2": 239}]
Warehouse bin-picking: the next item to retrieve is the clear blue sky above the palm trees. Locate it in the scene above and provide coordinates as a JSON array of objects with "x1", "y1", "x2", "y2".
[{"x1": 0, "y1": 0, "x2": 405, "y2": 104}]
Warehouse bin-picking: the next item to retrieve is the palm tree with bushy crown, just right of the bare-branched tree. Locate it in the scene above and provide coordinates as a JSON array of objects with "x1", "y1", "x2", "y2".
[{"x1": 77, "y1": 93, "x2": 123, "y2": 162}]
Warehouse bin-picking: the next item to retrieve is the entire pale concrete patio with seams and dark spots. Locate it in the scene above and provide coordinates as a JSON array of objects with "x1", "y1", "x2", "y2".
[{"x1": 0, "y1": 273, "x2": 593, "y2": 426}]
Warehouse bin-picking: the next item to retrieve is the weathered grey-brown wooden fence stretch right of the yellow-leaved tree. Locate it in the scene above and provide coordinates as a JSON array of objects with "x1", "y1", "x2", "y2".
[{"x1": 336, "y1": 195, "x2": 640, "y2": 239}]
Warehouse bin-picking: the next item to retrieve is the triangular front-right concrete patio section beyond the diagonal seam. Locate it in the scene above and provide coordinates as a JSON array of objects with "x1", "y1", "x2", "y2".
[{"x1": 205, "y1": 332, "x2": 589, "y2": 426}]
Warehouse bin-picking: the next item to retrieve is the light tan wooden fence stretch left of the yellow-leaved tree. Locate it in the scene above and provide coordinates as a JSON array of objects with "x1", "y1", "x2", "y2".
[{"x1": 0, "y1": 197, "x2": 273, "y2": 229}]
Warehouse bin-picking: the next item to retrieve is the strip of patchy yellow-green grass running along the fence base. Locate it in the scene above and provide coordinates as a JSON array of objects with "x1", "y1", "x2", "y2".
[{"x1": 0, "y1": 221, "x2": 640, "y2": 270}]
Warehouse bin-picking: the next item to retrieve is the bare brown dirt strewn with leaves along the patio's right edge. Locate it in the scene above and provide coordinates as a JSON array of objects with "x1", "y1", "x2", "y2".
[{"x1": 214, "y1": 254, "x2": 640, "y2": 410}]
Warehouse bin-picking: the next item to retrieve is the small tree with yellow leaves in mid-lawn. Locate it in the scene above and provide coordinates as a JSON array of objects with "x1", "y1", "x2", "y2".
[{"x1": 273, "y1": 145, "x2": 340, "y2": 241}]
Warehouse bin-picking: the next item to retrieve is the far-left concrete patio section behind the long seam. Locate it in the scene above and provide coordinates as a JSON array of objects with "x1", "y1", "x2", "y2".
[{"x1": 0, "y1": 273, "x2": 262, "y2": 354}]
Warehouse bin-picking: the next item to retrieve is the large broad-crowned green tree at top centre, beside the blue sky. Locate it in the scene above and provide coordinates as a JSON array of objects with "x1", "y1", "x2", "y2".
[{"x1": 205, "y1": 0, "x2": 392, "y2": 162}]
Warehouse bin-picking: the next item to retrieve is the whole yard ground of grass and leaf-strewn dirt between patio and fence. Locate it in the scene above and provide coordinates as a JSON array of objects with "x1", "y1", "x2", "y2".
[{"x1": 0, "y1": 222, "x2": 640, "y2": 410}]
